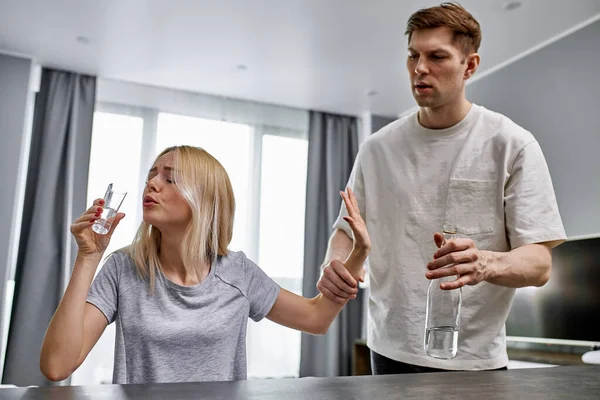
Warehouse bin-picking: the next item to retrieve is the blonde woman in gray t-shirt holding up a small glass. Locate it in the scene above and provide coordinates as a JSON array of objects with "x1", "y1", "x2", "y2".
[{"x1": 40, "y1": 146, "x2": 370, "y2": 384}]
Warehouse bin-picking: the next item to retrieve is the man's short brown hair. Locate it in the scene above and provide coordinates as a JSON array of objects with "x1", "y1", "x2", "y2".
[{"x1": 405, "y1": 3, "x2": 481, "y2": 55}]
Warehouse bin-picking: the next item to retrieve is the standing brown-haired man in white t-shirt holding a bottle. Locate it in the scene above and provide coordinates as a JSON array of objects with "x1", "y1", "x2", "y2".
[{"x1": 317, "y1": 3, "x2": 565, "y2": 374}]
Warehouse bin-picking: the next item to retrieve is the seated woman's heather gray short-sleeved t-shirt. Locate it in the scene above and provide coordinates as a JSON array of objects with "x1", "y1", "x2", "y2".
[{"x1": 87, "y1": 252, "x2": 280, "y2": 384}]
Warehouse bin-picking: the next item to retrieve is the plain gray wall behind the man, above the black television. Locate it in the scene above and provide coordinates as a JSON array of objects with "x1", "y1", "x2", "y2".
[{"x1": 467, "y1": 21, "x2": 600, "y2": 239}]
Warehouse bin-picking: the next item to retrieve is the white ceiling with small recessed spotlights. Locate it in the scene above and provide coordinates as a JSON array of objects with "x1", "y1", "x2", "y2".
[{"x1": 0, "y1": 0, "x2": 600, "y2": 116}]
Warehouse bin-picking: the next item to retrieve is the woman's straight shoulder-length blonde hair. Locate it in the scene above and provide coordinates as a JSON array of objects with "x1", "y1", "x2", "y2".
[{"x1": 128, "y1": 146, "x2": 235, "y2": 292}]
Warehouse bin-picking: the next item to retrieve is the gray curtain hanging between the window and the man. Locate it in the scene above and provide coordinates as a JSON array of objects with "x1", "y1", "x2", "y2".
[{"x1": 300, "y1": 111, "x2": 363, "y2": 377}]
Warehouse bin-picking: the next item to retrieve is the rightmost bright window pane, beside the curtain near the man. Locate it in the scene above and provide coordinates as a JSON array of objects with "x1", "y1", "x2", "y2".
[{"x1": 247, "y1": 135, "x2": 308, "y2": 377}]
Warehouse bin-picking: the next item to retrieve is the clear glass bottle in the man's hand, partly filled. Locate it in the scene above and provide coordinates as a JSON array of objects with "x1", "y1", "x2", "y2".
[{"x1": 425, "y1": 225, "x2": 462, "y2": 360}]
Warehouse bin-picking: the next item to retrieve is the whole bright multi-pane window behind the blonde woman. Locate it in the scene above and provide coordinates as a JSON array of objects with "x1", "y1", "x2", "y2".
[{"x1": 71, "y1": 103, "x2": 308, "y2": 385}]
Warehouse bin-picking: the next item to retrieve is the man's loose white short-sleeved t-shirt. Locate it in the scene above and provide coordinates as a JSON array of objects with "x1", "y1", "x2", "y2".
[{"x1": 334, "y1": 104, "x2": 566, "y2": 370}]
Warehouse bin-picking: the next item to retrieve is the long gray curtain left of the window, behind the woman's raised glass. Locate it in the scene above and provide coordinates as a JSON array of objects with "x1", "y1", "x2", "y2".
[{"x1": 2, "y1": 69, "x2": 96, "y2": 386}]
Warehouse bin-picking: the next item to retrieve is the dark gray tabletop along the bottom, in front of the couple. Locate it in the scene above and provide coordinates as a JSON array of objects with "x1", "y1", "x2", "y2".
[{"x1": 0, "y1": 365, "x2": 600, "y2": 400}]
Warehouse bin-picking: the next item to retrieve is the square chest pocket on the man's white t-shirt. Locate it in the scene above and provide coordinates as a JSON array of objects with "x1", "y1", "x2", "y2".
[{"x1": 445, "y1": 178, "x2": 497, "y2": 235}]
